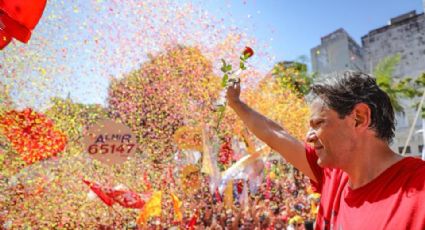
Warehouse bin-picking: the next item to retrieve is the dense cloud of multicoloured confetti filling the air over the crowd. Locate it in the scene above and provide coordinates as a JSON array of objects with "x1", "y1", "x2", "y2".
[{"x1": 0, "y1": 0, "x2": 308, "y2": 229}]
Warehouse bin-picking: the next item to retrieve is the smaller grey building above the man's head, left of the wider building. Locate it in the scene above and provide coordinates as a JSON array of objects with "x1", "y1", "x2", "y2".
[{"x1": 310, "y1": 28, "x2": 366, "y2": 77}]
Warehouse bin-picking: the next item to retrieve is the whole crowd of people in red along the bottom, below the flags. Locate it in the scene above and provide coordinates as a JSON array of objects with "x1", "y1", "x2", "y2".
[{"x1": 0, "y1": 157, "x2": 319, "y2": 229}]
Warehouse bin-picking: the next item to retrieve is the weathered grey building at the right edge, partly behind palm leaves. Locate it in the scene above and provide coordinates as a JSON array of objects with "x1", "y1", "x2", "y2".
[{"x1": 362, "y1": 11, "x2": 425, "y2": 155}]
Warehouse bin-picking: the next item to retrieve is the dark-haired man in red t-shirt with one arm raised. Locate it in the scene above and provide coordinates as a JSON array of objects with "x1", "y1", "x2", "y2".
[{"x1": 226, "y1": 72, "x2": 425, "y2": 230}]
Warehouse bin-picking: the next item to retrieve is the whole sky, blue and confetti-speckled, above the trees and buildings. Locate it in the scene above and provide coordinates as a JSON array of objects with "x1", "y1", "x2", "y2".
[{"x1": 0, "y1": 0, "x2": 423, "y2": 109}]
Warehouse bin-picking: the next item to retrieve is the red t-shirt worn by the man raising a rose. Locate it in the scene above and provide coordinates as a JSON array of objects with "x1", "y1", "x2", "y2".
[{"x1": 306, "y1": 145, "x2": 425, "y2": 230}]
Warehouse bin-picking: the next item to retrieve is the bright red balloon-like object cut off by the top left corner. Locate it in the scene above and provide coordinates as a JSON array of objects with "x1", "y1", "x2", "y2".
[{"x1": 0, "y1": 0, "x2": 46, "y2": 49}]
